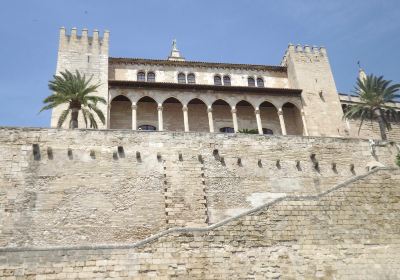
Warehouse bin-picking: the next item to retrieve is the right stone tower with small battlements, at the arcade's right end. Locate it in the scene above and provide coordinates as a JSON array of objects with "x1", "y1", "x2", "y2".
[{"x1": 281, "y1": 44, "x2": 343, "y2": 136}]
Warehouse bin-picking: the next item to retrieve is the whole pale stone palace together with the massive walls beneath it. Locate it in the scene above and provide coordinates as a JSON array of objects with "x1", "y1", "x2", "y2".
[{"x1": 0, "y1": 28, "x2": 400, "y2": 280}]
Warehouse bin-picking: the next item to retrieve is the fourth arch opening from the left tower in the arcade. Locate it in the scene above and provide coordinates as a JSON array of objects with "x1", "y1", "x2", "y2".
[{"x1": 187, "y1": 98, "x2": 209, "y2": 132}]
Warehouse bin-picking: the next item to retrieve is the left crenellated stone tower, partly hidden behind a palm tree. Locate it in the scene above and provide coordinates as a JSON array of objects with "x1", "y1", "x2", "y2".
[{"x1": 51, "y1": 27, "x2": 109, "y2": 128}]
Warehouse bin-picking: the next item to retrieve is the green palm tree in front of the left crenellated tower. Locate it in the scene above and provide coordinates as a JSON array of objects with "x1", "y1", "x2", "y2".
[{"x1": 40, "y1": 70, "x2": 107, "y2": 128}]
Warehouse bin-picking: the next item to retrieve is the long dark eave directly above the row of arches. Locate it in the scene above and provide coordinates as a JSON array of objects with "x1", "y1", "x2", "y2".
[{"x1": 108, "y1": 80, "x2": 302, "y2": 96}]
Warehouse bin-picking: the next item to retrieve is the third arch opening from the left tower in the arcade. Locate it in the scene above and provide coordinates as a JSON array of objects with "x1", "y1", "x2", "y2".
[{"x1": 162, "y1": 97, "x2": 184, "y2": 131}]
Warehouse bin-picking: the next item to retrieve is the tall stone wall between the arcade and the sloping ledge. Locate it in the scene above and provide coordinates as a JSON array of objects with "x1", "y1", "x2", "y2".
[{"x1": 0, "y1": 128, "x2": 398, "y2": 247}]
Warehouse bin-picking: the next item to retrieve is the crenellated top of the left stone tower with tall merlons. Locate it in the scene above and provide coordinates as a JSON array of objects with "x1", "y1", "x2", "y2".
[{"x1": 59, "y1": 27, "x2": 110, "y2": 53}]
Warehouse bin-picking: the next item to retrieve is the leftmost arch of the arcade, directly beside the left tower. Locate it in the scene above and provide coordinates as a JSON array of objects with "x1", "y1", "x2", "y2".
[{"x1": 110, "y1": 95, "x2": 132, "y2": 129}]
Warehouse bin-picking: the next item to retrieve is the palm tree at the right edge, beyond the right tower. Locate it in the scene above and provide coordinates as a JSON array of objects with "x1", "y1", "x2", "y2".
[{"x1": 344, "y1": 74, "x2": 400, "y2": 140}]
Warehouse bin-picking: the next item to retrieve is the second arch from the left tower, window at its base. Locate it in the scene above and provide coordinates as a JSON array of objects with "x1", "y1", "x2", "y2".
[{"x1": 136, "y1": 96, "x2": 158, "y2": 128}]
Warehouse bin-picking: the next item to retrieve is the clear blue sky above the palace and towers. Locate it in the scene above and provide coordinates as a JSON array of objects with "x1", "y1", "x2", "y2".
[{"x1": 0, "y1": 0, "x2": 400, "y2": 127}]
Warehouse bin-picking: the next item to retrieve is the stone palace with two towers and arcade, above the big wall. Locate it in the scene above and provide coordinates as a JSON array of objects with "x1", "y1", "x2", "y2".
[{"x1": 51, "y1": 28, "x2": 400, "y2": 138}]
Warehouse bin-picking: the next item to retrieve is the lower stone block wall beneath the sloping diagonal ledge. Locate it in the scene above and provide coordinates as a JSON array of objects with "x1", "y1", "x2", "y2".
[{"x1": 0, "y1": 169, "x2": 400, "y2": 279}]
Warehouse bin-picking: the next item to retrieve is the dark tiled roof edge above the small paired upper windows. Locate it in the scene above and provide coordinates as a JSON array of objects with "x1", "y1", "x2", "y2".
[{"x1": 108, "y1": 57, "x2": 287, "y2": 73}]
